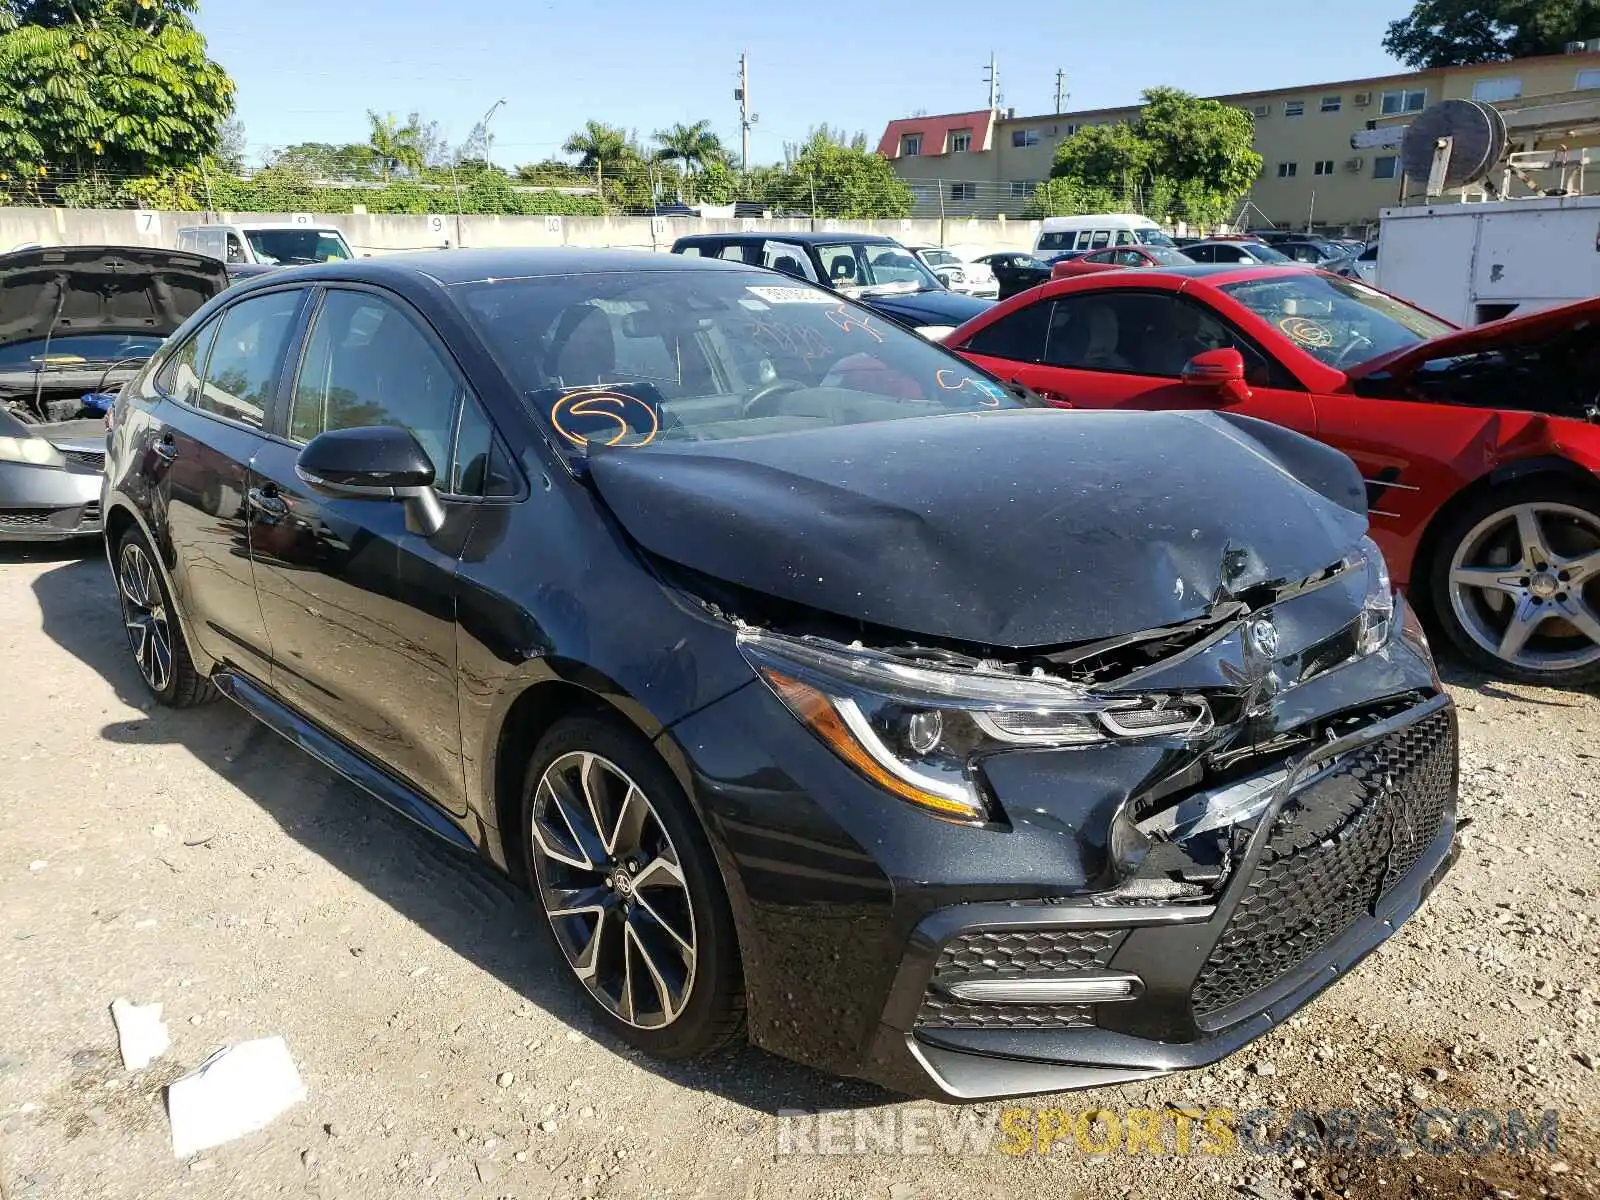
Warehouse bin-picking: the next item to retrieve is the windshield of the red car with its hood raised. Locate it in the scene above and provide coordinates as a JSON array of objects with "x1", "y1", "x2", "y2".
[{"x1": 1222, "y1": 272, "x2": 1451, "y2": 370}]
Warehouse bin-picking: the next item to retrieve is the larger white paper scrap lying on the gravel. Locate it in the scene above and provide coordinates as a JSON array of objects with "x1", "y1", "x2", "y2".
[{"x1": 166, "y1": 1037, "x2": 306, "y2": 1158}]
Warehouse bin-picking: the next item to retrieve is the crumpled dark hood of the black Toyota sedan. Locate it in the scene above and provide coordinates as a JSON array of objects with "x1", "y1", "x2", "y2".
[{"x1": 589, "y1": 408, "x2": 1366, "y2": 648}]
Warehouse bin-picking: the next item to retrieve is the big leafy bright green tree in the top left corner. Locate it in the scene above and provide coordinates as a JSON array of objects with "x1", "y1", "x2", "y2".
[{"x1": 0, "y1": 0, "x2": 234, "y2": 190}]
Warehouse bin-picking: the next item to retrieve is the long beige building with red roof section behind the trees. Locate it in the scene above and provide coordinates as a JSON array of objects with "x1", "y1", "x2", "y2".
[{"x1": 878, "y1": 42, "x2": 1600, "y2": 229}]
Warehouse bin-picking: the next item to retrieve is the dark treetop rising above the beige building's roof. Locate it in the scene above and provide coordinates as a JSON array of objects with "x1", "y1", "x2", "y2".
[{"x1": 1384, "y1": 0, "x2": 1600, "y2": 69}]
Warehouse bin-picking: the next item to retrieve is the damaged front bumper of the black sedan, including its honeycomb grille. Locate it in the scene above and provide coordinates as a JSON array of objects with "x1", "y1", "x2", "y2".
[{"x1": 672, "y1": 553, "x2": 1458, "y2": 1101}]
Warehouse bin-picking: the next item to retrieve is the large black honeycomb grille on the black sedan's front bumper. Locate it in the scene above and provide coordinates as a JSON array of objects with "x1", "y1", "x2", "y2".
[{"x1": 1194, "y1": 712, "x2": 1456, "y2": 1019}]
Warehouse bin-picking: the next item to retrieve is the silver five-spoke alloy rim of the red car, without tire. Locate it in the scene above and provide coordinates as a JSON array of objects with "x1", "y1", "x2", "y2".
[{"x1": 1450, "y1": 502, "x2": 1600, "y2": 672}]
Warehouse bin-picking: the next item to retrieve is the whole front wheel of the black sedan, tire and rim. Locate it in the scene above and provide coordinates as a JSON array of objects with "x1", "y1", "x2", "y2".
[{"x1": 522, "y1": 717, "x2": 744, "y2": 1059}]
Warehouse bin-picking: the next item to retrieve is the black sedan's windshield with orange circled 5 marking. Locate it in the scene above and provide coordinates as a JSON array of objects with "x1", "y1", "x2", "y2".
[{"x1": 454, "y1": 268, "x2": 1029, "y2": 454}]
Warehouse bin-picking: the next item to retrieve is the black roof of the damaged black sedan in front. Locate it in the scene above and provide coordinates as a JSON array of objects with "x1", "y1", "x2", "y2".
[{"x1": 222, "y1": 246, "x2": 760, "y2": 286}]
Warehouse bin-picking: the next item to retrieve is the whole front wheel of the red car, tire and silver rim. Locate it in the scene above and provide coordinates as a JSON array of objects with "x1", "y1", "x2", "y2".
[{"x1": 1430, "y1": 480, "x2": 1600, "y2": 686}]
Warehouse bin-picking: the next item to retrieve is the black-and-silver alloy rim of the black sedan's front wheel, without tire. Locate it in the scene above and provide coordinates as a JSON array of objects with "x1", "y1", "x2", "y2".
[{"x1": 530, "y1": 750, "x2": 696, "y2": 1029}]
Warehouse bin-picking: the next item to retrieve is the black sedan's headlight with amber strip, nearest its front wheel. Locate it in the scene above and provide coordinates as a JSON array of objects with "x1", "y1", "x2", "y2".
[{"x1": 739, "y1": 629, "x2": 1213, "y2": 821}]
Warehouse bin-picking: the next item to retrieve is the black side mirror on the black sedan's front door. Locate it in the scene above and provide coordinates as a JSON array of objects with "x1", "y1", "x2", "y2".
[{"x1": 294, "y1": 426, "x2": 445, "y2": 538}]
